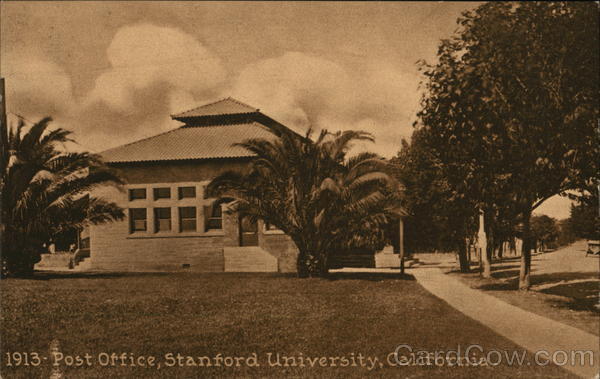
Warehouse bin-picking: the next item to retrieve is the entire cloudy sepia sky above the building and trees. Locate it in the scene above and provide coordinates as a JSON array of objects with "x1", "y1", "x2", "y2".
[{"x1": 0, "y1": 1, "x2": 569, "y2": 218}]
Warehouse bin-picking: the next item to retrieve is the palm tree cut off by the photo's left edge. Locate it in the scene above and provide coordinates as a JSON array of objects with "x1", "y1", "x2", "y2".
[{"x1": 0, "y1": 118, "x2": 124, "y2": 275}]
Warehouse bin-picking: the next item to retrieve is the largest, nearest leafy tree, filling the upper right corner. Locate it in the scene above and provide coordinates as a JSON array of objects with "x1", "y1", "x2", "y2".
[{"x1": 418, "y1": 2, "x2": 600, "y2": 289}]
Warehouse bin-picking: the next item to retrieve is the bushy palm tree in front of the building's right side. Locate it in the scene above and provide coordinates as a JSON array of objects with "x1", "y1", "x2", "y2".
[{"x1": 207, "y1": 129, "x2": 399, "y2": 277}]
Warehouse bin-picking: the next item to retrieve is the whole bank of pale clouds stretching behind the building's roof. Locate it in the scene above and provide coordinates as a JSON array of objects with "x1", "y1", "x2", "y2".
[{"x1": 2, "y1": 41, "x2": 418, "y2": 156}]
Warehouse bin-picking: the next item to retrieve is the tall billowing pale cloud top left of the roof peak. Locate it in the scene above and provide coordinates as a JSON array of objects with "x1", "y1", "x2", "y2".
[{"x1": 85, "y1": 24, "x2": 226, "y2": 111}]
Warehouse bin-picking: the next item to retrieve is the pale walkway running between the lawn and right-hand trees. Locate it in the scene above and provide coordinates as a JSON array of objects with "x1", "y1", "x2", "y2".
[{"x1": 407, "y1": 268, "x2": 600, "y2": 378}]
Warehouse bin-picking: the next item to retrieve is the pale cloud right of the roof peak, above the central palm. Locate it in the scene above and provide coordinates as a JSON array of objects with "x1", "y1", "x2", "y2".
[{"x1": 233, "y1": 52, "x2": 418, "y2": 156}]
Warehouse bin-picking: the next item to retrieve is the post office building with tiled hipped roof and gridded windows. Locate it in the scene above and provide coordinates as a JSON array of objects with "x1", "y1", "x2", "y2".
[{"x1": 85, "y1": 98, "x2": 297, "y2": 272}]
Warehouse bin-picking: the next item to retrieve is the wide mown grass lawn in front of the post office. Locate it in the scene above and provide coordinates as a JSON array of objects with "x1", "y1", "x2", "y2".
[{"x1": 0, "y1": 274, "x2": 570, "y2": 378}]
